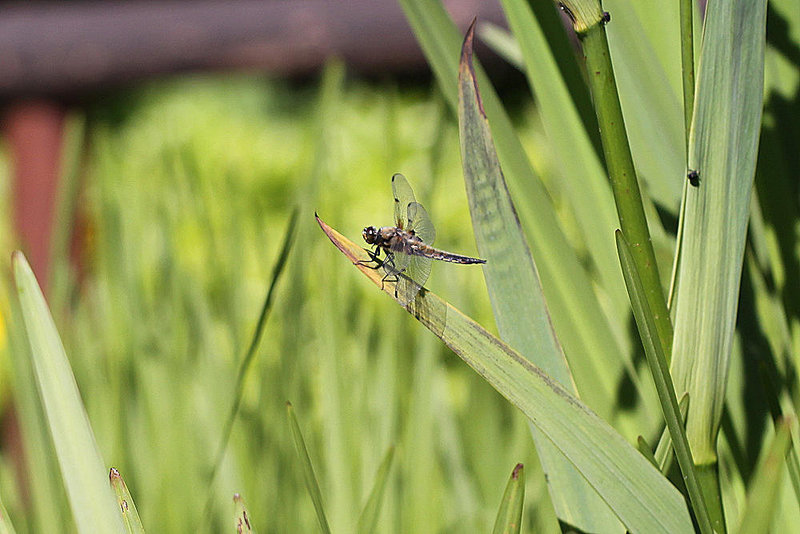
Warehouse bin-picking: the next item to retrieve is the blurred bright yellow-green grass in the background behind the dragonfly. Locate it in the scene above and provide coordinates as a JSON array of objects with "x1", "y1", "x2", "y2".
[{"x1": 0, "y1": 69, "x2": 564, "y2": 532}]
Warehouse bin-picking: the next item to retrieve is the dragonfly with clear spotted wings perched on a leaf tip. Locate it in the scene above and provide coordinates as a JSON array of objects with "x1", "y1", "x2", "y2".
[{"x1": 361, "y1": 174, "x2": 486, "y2": 305}]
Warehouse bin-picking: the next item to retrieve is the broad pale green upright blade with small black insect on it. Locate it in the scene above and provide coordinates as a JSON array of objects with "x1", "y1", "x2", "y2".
[{"x1": 672, "y1": 0, "x2": 766, "y2": 520}]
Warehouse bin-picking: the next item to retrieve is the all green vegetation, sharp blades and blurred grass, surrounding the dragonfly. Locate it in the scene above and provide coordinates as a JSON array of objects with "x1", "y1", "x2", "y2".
[{"x1": 0, "y1": 0, "x2": 800, "y2": 533}]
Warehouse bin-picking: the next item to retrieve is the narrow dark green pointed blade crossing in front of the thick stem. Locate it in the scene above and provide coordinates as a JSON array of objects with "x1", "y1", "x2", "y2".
[{"x1": 616, "y1": 230, "x2": 713, "y2": 534}]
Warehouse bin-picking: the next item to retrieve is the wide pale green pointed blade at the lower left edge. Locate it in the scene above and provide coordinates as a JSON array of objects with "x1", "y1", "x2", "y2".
[{"x1": 12, "y1": 252, "x2": 125, "y2": 533}]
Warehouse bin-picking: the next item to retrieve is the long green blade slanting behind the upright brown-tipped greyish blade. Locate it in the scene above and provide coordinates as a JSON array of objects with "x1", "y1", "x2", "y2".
[{"x1": 401, "y1": 0, "x2": 641, "y2": 448}]
